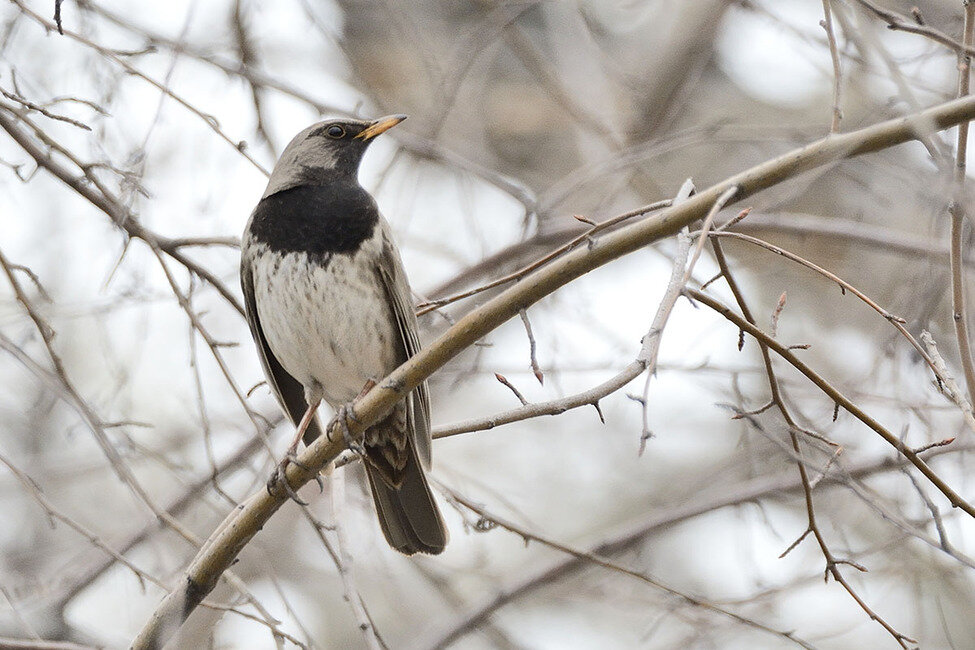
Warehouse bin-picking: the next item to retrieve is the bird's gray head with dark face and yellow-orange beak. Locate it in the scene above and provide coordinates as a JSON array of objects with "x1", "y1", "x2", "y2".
[{"x1": 261, "y1": 115, "x2": 406, "y2": 198}]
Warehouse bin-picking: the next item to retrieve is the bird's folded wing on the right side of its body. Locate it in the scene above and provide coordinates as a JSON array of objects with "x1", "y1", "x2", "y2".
[{"x1": 378, "y1": 222, "x2": 431, "y2": 467}]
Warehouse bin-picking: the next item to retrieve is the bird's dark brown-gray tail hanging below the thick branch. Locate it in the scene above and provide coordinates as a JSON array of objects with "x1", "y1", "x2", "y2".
[{"x1": 363, "y1": 437, "x2": 447, "y2": 555}]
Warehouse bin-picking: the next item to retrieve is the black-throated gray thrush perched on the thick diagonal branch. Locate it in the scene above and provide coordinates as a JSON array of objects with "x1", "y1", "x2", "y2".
[{"x1": 240, "y1": 115, "x2": 448, "y2": 555}]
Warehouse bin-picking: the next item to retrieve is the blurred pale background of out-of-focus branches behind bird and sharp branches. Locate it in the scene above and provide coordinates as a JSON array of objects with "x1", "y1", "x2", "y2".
[{"x1": 0, "y1": 0, "x2": 975, "y2": 648}]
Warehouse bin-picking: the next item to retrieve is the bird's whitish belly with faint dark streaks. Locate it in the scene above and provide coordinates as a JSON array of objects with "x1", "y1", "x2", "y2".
[{"x1": 253, "y1": 235, "x2": 401, "y2": 406}]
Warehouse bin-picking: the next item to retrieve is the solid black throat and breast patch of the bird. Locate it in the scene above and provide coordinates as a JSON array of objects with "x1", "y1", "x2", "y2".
[{"x1": 250, "y1": 178, "x2": 379, "y2": 263}]
